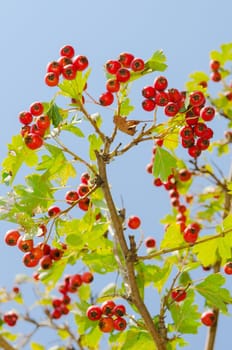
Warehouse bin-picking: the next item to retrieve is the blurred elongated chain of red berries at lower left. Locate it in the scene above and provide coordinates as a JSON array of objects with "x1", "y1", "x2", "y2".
[{"x1": 50, "y1": 271, "x2": 94, "y2": 319}]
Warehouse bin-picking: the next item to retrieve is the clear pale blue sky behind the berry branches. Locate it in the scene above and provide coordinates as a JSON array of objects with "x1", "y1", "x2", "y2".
[{"x1": 0, "y1": 0, "x2": 232, "y2": 350}]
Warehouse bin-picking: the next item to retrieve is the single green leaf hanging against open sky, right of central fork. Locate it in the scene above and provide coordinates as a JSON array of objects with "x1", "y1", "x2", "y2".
[{"x1": 153, "y1": 147, "x2": 176, "y2": 181}]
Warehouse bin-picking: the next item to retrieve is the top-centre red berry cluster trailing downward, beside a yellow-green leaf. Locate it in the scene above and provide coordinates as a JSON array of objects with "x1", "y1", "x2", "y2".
[{"x1": 99, "y1": 52, "x2": 145, "y2": 106}]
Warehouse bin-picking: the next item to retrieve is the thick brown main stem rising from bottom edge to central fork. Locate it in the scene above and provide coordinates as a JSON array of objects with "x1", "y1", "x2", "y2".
[{"x1": 96, "y1": 152, "x2": 166, "y2": 350}]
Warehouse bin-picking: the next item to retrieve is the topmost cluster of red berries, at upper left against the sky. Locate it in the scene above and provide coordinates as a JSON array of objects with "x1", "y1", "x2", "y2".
[{"x1": 44, "y1": 45, "x2": 89, "y2": 86}]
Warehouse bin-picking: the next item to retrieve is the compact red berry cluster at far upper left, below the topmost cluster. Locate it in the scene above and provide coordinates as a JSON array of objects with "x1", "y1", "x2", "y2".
[{"x1": 18, "y1": 102, "x2": 50, "y2": 150}]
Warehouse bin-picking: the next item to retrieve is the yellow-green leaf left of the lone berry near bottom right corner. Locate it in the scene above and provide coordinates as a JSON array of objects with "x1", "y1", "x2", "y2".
[{"x1": 170, "y1": 290, "x2": 201, "y2": 334}]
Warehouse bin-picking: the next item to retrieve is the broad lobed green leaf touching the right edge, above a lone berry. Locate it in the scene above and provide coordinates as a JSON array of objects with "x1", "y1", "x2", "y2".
[{"x1": 195, "y1": 273, "x2": 232, "y2": 312}]
